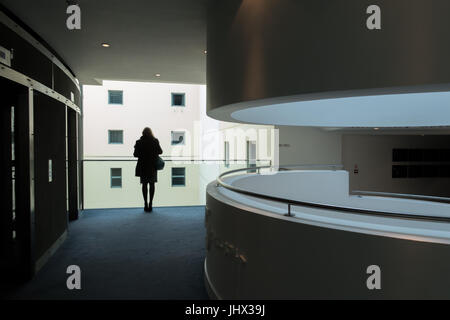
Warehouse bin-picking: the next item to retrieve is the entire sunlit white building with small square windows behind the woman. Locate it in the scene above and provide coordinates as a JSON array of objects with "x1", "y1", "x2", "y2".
[{"x1": 83, "y1": 81, "x2": 278, "y2": 208}]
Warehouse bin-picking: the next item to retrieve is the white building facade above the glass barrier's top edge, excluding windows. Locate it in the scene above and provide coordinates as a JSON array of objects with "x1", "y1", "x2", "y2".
[{"x1": 83, "y1": 81, "x2": 273, "y2": 160}]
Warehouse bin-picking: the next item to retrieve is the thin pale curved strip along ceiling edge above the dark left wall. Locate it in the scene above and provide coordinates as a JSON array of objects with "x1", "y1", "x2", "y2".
[{"x1": 0, "y1": 11, "x2": 81, "y2": 91}]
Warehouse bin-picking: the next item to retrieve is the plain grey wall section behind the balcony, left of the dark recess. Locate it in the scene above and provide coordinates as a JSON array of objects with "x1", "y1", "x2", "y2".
[{"x1": 277, "y1": 126, "x2": 342, "y2": 165}]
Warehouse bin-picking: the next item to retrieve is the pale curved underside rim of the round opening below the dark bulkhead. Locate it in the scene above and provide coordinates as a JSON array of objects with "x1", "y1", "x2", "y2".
[{"x1": 207, "y1": 84, "x2": 450, "y2": 128}]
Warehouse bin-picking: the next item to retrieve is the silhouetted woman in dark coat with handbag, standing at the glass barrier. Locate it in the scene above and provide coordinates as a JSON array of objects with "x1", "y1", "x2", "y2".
[{"x1": 133, "y1": 127, "x2": 162, "y2": 212}]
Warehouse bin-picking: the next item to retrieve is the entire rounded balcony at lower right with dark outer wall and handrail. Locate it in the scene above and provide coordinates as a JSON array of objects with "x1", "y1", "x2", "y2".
[{"x1": 205, "y1": 166, "x2": 450, "y2": 299}]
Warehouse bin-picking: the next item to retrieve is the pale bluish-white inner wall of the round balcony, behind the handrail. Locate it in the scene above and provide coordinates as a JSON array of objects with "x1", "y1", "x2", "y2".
[{"x1": 227, "y1": 170, "x2": 450, "y2": 217}]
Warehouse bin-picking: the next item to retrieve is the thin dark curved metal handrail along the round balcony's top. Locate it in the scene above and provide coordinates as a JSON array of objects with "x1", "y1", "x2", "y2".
[{"x1": 216, "y1": 165, "x2": 450, "y2": 222}]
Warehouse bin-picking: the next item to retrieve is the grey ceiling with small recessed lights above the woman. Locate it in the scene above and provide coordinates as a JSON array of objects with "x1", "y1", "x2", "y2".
[{"x1": 0, "y1": 0, "x2": 207, "y2": 84}]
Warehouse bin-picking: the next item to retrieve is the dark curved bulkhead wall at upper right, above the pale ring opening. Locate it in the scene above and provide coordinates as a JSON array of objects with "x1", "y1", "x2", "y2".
[{"x1": 207, "y1": 0, "x2": 450, "y2": 124}]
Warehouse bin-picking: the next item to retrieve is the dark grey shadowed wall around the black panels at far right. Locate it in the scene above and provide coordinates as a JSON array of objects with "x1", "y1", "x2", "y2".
[{"x1": 342, "y1": 134, "x2": 450, "y2": 197}]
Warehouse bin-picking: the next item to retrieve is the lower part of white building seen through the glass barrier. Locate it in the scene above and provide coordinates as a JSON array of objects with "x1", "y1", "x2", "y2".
[{"x1": 83, "y1": 159, "x2": 270, "y2": 209}]
